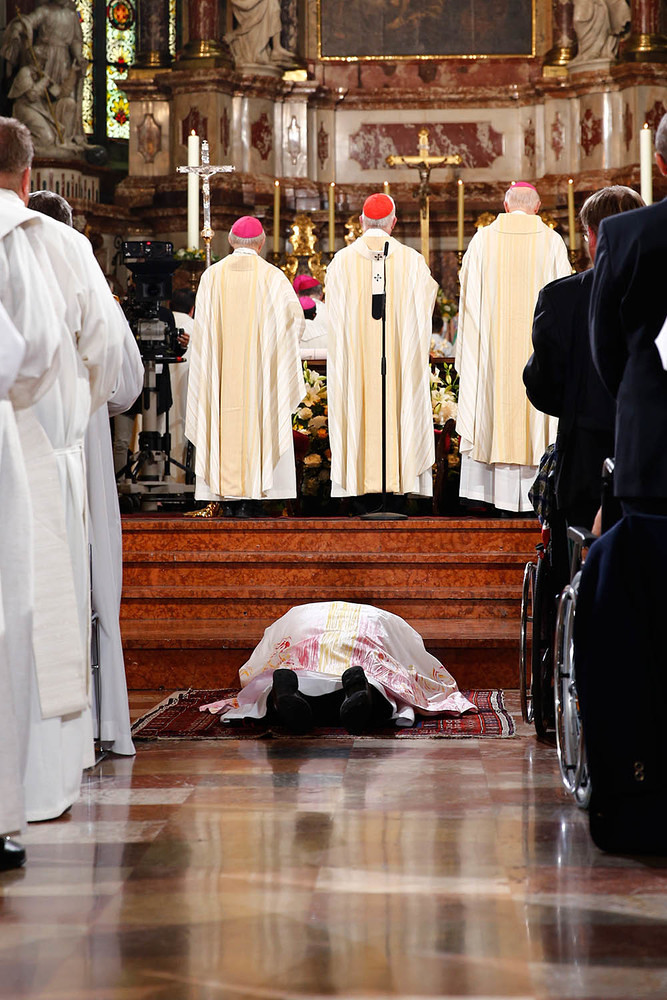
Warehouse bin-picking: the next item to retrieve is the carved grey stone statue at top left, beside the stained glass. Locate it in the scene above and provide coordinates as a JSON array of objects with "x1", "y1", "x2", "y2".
[{"x1": 0, "y1": 0, "x2": 88, "y2": 157}]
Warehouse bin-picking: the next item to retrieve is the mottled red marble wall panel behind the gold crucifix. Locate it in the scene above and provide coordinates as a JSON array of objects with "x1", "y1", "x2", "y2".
[{"x1": 350, "y1": 122, "x2": 503, "y2": 170}]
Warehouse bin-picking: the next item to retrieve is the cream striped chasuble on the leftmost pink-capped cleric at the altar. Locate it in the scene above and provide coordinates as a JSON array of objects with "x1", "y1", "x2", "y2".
[{"x1": 185, "y1": 249, "x2": 306, "y2": 500}]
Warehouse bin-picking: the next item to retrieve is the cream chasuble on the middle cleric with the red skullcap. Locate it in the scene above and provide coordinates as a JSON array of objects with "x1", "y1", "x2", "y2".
[{"x1": 326, "y1": 229, "x2": 438, "y2": 496}]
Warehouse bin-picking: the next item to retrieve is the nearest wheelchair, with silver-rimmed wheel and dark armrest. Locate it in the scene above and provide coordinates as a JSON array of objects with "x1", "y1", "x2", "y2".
[{"x1": 553, "y1": 458, "x2": 621, "y2": 809}]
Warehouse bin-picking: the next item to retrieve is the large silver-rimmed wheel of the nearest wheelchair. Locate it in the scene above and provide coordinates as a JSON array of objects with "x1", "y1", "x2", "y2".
[{"x1": 554, "y1": 573, "x2": 591, "y2": 809}]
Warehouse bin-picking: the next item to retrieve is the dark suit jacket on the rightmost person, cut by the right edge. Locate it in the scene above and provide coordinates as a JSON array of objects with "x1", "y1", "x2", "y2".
[{"x1": 590, "y1": 199, "x2": 667, "y2": 499}]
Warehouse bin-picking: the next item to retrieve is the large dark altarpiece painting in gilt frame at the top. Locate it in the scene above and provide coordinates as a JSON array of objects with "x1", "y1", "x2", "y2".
[{"x1": 318, "y1": 0, "x2": 534, "y2": 59}]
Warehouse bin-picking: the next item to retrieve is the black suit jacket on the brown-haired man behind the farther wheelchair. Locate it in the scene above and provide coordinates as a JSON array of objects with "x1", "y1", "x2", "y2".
[{"x1": 523, "y1": 270, "x2": 615, "y2": 528}]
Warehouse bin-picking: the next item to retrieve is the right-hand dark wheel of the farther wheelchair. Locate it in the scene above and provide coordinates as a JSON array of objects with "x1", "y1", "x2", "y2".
[{"x1": 531, "y1": 545, "x2": 555, "y2": 739}]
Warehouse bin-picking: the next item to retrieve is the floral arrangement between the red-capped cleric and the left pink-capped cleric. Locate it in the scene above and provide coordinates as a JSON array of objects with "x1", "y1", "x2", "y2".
[{"x1": 292, "y1": 362, "x2": 331, "y2": 500}]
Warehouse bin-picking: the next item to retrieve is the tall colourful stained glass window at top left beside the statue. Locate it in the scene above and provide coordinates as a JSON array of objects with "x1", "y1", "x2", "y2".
[{"x1": 74, "y1": 0, "x2": 177, "y2": 141}]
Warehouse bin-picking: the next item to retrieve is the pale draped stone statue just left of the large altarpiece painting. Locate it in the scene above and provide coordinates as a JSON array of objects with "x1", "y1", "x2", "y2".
[{"x1": 225, "y1": 0, "x2": 294, "y2": 66}]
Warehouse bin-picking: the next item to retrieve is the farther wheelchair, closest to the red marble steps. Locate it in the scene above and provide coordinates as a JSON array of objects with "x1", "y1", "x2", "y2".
[{"x1": 519, "y1": 514, "x2": 567, "y2": 739}]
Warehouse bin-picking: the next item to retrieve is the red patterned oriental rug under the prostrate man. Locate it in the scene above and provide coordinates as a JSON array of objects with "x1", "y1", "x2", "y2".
[{"x1": 132, "y1": 688, "x2": 516, "y2": 740}]
